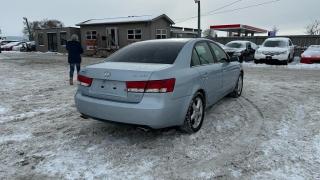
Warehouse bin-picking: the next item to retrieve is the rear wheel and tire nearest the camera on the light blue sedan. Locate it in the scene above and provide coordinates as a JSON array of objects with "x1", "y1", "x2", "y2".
[{"x1": 180, "y1": 92, "x2": 205, "y2": 134}]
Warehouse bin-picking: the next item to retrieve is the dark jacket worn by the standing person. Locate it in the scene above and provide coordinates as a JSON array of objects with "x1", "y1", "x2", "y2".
[{"x1": 66, "y1": 41, "x2": 83, "y2": 64}]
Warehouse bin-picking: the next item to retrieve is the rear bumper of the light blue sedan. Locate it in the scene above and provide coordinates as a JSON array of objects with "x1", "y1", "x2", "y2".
[{"x1": 75, "y1": 92, "x2": 191, "y2": 129}]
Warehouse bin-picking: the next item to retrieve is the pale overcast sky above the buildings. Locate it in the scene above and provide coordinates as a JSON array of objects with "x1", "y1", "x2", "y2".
[{"x1": 0, "y1": 0, "x2": 320, "y2": 35}]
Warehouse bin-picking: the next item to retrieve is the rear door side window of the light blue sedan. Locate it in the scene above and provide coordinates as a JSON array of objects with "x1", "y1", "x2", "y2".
[{"x1": 195, "y1": 42, "x2": 214, "y2": 64}]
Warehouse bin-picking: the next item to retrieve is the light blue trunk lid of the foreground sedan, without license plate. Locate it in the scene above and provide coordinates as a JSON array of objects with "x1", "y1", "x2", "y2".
[{"x1": 81, "y1": 62, "x2": 172, "y2": 103}]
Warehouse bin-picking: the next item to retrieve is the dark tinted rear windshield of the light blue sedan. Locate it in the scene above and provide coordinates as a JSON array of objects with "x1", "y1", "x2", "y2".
[{"x1": 106, "y1": 42, "x2": 185, "y2": 64}]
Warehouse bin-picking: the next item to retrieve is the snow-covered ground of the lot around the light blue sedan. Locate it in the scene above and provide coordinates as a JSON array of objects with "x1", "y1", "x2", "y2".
[{"x1": 0, "y1": 53, "x2": 320, "y2": 179}]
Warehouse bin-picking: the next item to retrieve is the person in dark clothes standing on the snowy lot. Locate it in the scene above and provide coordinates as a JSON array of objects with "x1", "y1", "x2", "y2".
[{"x1": 66, "y1": 34, "x2": 83, "y2": 85}]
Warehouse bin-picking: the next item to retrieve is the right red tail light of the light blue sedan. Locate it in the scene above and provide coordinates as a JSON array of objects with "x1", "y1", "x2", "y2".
[{"x1": 126, "y1": 79, "x2": 176, "y2": 93}]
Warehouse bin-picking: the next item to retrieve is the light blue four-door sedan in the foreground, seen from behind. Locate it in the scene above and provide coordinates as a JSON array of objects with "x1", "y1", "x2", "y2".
[{"x1": 75, "y1": 39, "x2": 243, "y2": 133}]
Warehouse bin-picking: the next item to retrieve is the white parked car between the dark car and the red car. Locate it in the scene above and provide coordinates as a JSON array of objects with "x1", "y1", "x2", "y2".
[{"x1": 254, "y1": 38, "x2": 294, "y2": 65}]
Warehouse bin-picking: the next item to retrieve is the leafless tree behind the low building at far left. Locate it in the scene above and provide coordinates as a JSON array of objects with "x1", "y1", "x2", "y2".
[{"x1": 22, "y1": 19, "x2": 64, "y2": 37}]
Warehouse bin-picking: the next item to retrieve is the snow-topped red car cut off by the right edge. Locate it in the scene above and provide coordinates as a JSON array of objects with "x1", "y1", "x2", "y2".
[{"x1": 300, "y1": 45, "x2": 320, "y2": 64}]
